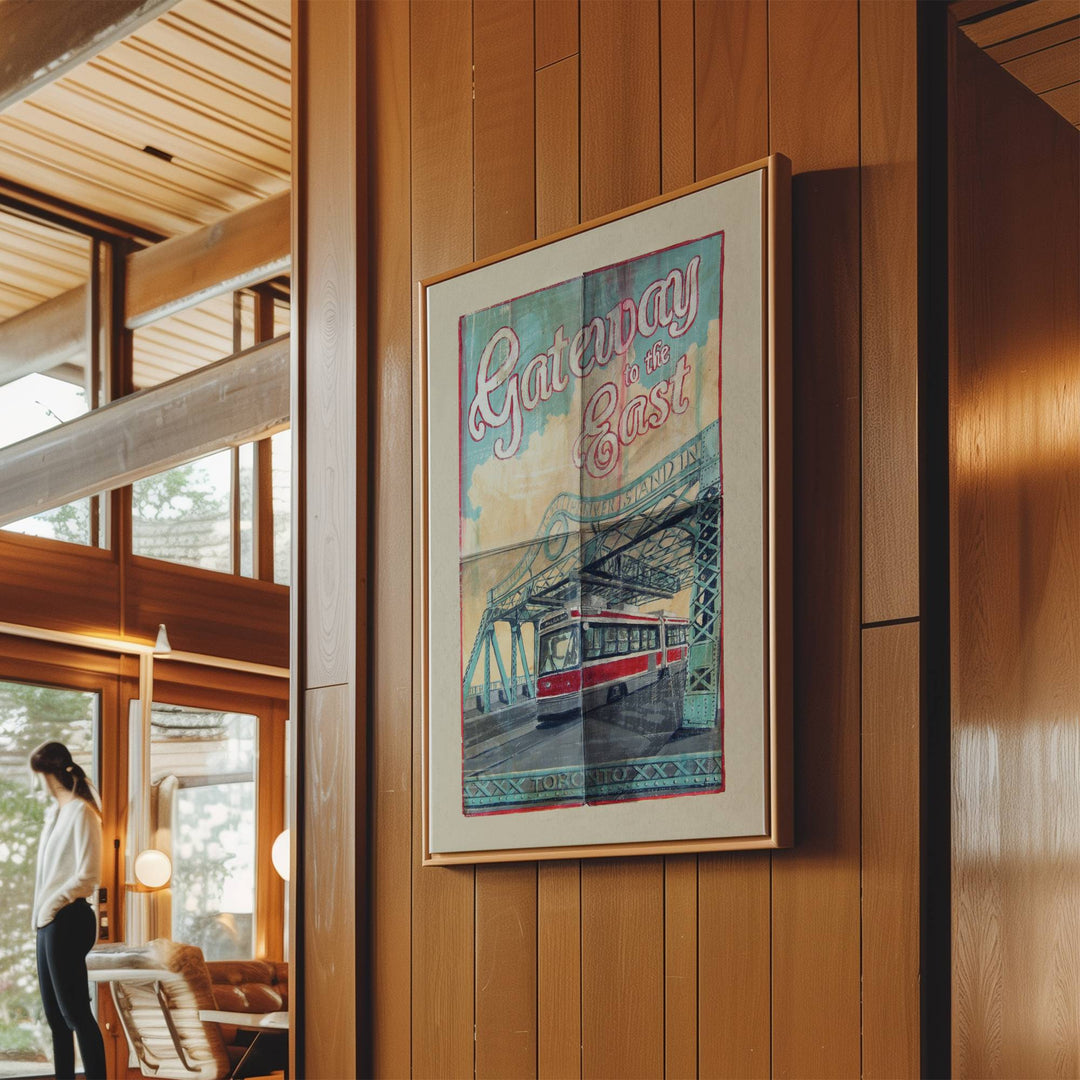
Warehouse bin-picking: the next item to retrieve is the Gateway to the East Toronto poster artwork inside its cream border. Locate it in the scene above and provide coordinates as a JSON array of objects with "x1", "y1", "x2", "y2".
[{"x1": 459, "y1": 232, "x2": 725, "y2": 815}]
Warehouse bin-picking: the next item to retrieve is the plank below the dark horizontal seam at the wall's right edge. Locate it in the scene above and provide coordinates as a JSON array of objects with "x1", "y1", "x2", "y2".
[{"x1": 862, "y1": 622, "x2": 921, "y2": 1080}]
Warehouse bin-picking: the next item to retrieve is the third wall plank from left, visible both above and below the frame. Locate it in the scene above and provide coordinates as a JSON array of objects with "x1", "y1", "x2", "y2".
[{"x1": 473, "y1": 8, "x2": 537, "y2": 1080}]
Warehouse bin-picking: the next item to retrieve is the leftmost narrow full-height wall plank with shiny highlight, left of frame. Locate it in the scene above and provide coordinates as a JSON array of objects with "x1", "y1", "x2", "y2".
[{"x1": 368, "y1": 0, "x2": 413, "y2": 1077}]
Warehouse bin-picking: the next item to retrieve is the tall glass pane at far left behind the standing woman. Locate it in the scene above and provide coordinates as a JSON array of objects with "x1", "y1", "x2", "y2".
[{"x1": 0, "y1": 681, "x2": 99, "y2": 1077}]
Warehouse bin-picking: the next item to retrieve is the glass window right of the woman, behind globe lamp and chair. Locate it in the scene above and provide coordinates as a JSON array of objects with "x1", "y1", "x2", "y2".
[{"x1": 150, "y1": 704, "x2": 258, "y2": 960}]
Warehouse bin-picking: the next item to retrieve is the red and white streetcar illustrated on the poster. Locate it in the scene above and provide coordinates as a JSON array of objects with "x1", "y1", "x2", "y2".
[{"x1": 537, "y1": 608, "x2": 688, "y2": 724}]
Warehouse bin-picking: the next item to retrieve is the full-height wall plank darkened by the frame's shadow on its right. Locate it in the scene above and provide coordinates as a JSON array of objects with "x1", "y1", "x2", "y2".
[{"x1": 769, "y1": 0, "x2": 861, "y2": 1077}]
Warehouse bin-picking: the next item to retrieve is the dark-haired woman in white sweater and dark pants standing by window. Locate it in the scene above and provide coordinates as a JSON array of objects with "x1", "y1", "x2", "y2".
[{"x1": 30, "y1": 742, "x2": 105, "y2": 1080}]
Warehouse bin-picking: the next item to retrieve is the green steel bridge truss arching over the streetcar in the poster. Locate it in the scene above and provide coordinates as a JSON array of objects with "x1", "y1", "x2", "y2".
[{"x1": 462, "y1": 421, "x2": 724, "y2": 729}]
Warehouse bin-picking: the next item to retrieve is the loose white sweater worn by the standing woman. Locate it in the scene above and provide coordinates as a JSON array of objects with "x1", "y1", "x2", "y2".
[{"x1": 32, "y1": 798, "x2": 102, "y2": 930}]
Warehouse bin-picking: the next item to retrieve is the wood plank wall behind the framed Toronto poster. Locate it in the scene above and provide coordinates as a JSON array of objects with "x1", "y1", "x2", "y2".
[{"x1": 362, "y1": 0, "x2": 919, "y2": 1077}]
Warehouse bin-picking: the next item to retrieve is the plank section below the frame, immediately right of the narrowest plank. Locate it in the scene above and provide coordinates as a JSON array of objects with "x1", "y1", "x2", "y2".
[{"x1": 698, "y1": 852, "x2": 773, "y2": 1080}]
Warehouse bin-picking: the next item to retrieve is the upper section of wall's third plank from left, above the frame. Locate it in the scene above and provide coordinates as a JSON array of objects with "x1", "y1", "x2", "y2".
[{"x1": 473, "y1": 0, "x2": 536, "y2": 258}]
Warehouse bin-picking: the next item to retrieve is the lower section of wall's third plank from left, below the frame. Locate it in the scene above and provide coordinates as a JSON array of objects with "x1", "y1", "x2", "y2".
[{"x1": 475, "y1": 863, "x2": 537, "y2": 1080}]
